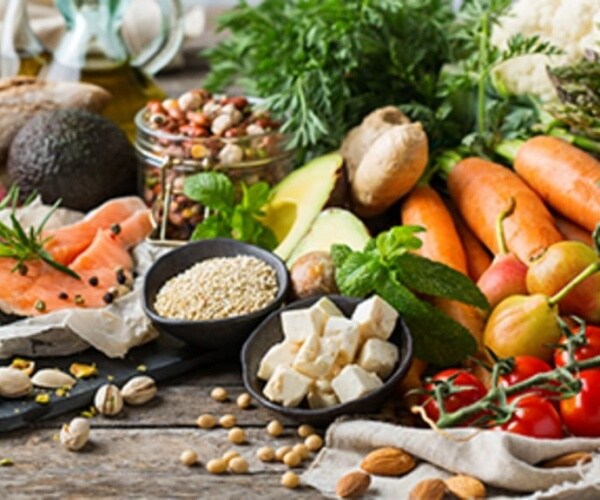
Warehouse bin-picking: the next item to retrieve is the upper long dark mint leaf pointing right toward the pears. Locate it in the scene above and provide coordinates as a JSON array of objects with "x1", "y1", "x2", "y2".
[{"x1": 393, "y1": 253, "x2": 490, "y2": 309}]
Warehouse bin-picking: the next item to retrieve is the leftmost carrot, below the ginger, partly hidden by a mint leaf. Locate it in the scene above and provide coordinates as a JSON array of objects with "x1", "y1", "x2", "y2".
[{"x1": 401, "y1": 185, "x2": 483, "y2": 346}]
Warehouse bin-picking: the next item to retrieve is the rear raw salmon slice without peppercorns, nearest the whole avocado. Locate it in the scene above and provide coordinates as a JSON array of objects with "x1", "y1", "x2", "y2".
[{"x1": 44, "y1": 196, "x2": 147, "y2": 265}]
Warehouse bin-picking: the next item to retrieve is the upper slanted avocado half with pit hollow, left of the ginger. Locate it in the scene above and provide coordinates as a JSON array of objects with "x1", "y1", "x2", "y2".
[{"x1": 263, "y1": 153, "x2": 344, "y2": 260}]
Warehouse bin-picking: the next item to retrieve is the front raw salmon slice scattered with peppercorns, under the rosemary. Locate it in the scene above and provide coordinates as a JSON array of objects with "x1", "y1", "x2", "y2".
[{"x1": 0, "y1": 209, "x2": 153, "y2": 316}]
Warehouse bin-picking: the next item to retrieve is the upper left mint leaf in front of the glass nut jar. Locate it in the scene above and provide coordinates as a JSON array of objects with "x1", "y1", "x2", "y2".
[{"x1": 183, "y1": 172, "x2": 235, "y2": 213}]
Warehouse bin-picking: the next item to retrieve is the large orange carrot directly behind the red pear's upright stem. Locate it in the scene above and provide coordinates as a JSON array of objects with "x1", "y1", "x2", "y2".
[{"x1": 448, "y1": 158, "x2": 563, "y2": 263}]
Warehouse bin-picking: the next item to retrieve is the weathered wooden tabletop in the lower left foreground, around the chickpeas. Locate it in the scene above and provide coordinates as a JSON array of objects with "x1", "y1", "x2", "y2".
[{"x1": 0, "y1": 363, "x2": 328, "y2": 500}]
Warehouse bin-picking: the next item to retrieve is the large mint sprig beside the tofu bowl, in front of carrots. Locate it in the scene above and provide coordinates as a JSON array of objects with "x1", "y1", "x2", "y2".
[{"x1": 331, "y1": 226, "x2": 489, "y2": 366}]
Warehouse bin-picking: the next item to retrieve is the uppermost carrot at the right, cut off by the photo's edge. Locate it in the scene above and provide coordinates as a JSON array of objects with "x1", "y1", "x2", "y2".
[{"x1": 514, "y1": 136, "x2": 600, "y2": 232}]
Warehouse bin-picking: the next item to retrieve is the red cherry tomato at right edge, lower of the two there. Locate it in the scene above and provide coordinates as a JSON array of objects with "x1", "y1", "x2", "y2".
[{"x1": 560, "y1": 368, "x2": 600, "y2": 437}]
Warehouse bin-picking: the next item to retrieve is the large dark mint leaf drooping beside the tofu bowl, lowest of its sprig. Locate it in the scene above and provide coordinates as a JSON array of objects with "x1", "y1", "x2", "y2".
[{"x1": 375, "y1": 276, "x2": 477, "y2": 366}]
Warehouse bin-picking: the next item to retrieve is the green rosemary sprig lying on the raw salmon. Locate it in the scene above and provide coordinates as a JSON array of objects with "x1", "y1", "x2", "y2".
[{"x1": 0, "y1": 186, "x2": 81, "y2": 280}]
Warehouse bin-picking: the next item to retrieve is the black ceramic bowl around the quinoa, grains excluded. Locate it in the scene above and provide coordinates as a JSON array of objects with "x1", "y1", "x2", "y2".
[{"x1": 143, "y1": 238, "x2": 289, "y2": 350}]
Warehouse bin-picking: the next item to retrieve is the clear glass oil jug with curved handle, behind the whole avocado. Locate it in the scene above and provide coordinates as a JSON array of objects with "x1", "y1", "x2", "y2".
[{"x1": 44, "y1": 0, "x2": 183, "y2": 140}]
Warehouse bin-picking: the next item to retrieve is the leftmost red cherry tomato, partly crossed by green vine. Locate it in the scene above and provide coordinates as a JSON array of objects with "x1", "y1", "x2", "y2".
[{"x1": 424, "y1": 368, "x2": 487, "y2": 422}]
